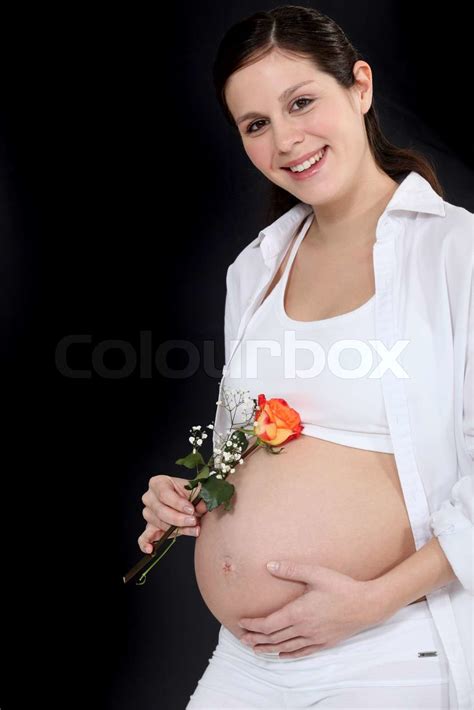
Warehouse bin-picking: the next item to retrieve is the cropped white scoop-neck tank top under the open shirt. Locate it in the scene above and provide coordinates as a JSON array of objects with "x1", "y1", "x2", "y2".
[{"x1": 223, "y1": 213, "x2": 393, "y2": 453}]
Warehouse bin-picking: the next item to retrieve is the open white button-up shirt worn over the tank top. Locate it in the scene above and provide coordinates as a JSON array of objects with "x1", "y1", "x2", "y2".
[{"x1": 214, "y1": 171, "x2": 474, "y2": 710}]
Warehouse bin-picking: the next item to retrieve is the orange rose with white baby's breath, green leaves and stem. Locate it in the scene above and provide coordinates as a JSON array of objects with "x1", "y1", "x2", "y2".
[{"x1": 123, "y1": 387, "x2": 304, "y2": 585}]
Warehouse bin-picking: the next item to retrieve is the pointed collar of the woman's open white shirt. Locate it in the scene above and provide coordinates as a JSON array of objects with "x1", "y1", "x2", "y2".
[{"x1": 252, "y1": 170, "x2": 445, "y2": 263}]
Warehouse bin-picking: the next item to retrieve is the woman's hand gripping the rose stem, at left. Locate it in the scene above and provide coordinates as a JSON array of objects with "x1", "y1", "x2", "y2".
[{"x1": 138, "y1": 475, "x2": 207, "y2": 553}]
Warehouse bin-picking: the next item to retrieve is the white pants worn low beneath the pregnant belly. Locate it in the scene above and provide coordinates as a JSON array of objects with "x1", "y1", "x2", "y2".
[{"x1": 186, "y1": 600, "x2": 449, "y2": 710}]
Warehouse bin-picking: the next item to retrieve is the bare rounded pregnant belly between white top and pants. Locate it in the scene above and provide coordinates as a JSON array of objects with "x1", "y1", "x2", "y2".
[{"x1": 194, "y1": 436, "x2": 424, "y2": 637}]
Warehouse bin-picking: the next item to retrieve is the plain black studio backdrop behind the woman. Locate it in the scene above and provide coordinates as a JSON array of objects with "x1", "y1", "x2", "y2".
[{"x1": 0, "y1": 0, "x2": 474, "y2": 710}]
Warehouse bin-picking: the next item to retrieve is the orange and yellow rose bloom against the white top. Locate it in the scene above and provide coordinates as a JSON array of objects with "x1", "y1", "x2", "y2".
[{"x1": 254, "y1": 394, "x2": 304, "y2": 446}]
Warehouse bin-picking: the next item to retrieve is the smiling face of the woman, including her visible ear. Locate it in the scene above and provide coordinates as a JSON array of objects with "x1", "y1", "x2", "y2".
[{"x1": 225, "y1": 50, "x2": 373, "y2": 205}]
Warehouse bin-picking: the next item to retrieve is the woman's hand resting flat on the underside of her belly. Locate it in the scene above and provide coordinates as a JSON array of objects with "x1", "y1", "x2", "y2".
[{"x1": 239, "y1": 560, "x2": 383, "y2": 658}]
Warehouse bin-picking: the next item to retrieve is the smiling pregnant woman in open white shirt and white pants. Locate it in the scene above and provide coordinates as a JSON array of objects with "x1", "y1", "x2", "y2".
[{"x1": 139, "y1": 6, "x2": 474, "y2": 710}]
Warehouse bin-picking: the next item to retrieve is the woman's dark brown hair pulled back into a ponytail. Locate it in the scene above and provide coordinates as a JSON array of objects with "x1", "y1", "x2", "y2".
[{"x1": 213, "y1": 5, "x2": 444, "y2": 221}]
